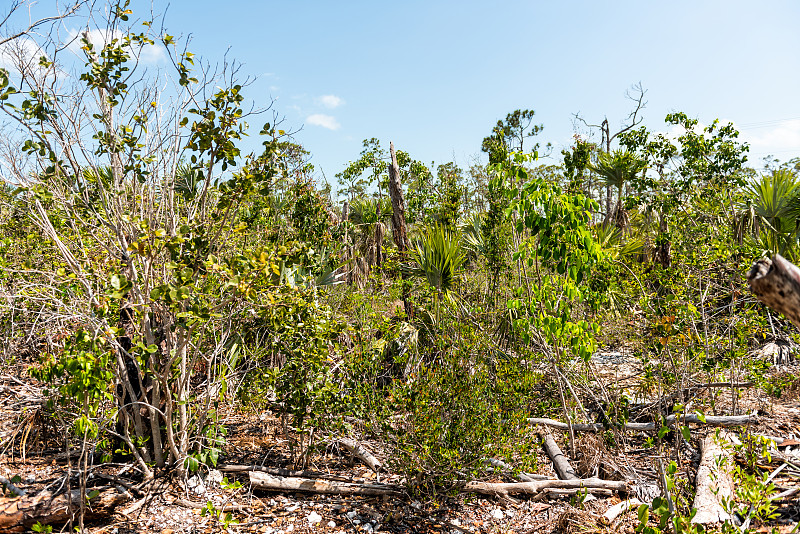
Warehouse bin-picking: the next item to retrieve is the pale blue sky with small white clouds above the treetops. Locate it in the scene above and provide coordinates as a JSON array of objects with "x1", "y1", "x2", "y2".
[{"x1": 9, "y1": 0, "x2": 800, "y2": 197}]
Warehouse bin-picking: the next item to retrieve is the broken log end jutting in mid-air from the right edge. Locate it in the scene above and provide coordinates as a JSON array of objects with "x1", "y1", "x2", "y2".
[{"x1": 747, "y1": 254, "x2": 800, "y2": 328}]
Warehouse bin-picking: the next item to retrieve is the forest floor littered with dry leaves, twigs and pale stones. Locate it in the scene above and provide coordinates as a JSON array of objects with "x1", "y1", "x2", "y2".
[{"x1": 0, "y1": 354, "x2": 800, "y2": 534}]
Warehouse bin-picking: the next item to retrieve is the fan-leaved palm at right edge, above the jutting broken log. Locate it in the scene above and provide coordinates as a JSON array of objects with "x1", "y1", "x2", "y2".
[{"x1": 735, "y1": 169, "x2": 800, "y2": 259}]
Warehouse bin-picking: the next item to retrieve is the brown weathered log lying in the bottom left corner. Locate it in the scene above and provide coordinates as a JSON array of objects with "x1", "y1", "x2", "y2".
[{"x1": 0, "y1": 487, "x2": 130, "y2": 533}]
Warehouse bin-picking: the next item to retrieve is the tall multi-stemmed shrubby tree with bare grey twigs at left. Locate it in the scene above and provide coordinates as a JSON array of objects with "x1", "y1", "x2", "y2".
[{"x1": 0, "y1": 2, "x2": 332, "y2": 478}]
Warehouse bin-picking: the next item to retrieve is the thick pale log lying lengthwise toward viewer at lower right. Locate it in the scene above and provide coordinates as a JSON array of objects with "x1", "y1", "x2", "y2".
[{"x1": 692, "y1": 433, "x2": 733, "y2": 525}]
